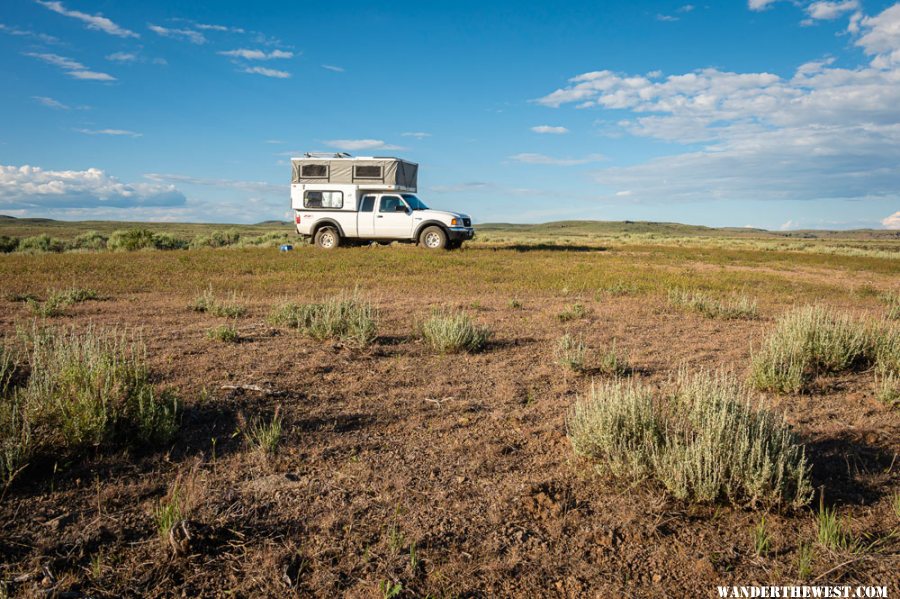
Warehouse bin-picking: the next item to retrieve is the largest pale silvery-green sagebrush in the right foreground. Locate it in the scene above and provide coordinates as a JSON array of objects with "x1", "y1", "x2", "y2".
[{"x1": 567, "y1": 372, "x2": 812, "y2": 506}]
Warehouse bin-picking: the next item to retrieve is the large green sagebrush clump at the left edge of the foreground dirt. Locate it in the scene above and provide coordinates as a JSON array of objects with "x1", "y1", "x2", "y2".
[{"x1": 0, "y1": 327, "x2": 177, "y2": 486}]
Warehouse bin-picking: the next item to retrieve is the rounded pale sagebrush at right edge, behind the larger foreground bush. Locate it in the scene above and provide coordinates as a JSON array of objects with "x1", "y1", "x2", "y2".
[{"x1": 750, "y1": 305, "x2": 884, "y2": 393}]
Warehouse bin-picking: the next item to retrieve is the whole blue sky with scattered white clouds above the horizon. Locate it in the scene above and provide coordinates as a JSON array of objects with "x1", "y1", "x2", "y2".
[{"x1": 0, "y1": 0, "x2": 900, "y2": 229}]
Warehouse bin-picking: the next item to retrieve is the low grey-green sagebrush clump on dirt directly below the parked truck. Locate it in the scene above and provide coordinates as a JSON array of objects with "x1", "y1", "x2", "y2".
[{"x1": 269, "y1": 293, "x2": 378, "y2": 347}]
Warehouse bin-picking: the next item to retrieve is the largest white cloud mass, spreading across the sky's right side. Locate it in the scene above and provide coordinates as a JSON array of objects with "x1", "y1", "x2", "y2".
[{"x1": 536, "y1": 4, "x2": 900, "y2": 207}]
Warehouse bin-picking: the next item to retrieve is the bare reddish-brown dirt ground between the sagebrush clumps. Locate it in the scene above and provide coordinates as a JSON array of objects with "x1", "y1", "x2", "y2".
[{"x1": 0, "y1": 249, "x2": 900, "y2": 597}]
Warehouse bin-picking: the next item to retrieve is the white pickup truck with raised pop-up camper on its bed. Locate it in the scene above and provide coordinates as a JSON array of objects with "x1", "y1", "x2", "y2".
[{"x1": 291, "y1": 154, "x2": 475, "y2": 249}]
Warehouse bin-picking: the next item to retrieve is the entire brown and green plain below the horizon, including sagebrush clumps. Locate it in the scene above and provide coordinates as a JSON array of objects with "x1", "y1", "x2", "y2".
[{"x1": 0, "y1": 219, "x2": 900, "y2": 597}]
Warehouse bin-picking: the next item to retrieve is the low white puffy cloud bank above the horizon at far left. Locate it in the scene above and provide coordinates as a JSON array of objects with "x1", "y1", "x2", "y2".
[{"x1": 0, "y1": 165, "x2": 185, "y2": 216}]
